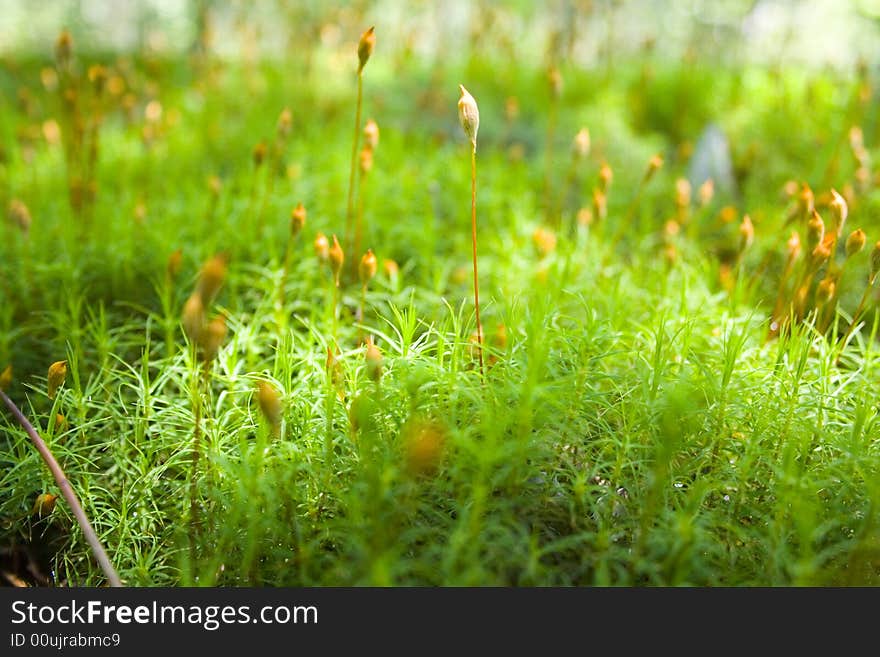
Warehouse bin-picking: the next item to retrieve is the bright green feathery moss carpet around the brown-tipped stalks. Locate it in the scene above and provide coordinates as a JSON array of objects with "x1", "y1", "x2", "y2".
[{"x1": 0, "y1": 51, "x2": 880, "y2": 586}]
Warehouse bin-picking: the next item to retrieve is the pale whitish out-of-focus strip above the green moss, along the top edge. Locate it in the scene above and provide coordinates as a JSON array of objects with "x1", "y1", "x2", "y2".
[{"x1": 0, "y1": 0, "x2": 880, "y2": 69}]
